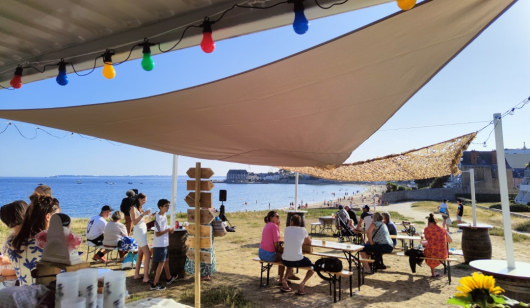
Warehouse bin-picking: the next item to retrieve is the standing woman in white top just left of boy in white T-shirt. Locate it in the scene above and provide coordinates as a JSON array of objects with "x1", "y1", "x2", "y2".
[{"x1": 129, "y1": 193, "x2": 151, "y2": 283}]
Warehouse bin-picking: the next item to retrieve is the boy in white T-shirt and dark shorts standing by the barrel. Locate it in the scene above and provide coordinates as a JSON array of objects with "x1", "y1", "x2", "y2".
[{"x1": 151, "y1": 199, "x2": 177, "y2": 291}]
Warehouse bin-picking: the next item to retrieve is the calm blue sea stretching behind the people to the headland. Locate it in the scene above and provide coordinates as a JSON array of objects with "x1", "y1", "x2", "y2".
[{"x1": 0, "y1": 176, "x2": 365, "y2": 218}]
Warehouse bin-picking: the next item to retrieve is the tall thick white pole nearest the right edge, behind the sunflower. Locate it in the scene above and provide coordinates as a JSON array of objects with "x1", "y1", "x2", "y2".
[{"x1": 493, "y1": 113, "x2": 515, "y2": 269}]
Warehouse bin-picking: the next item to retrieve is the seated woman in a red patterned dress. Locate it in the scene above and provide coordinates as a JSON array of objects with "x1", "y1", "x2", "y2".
[{"x1": 422, "y1": 213, "x2": 453, "y2": 277}]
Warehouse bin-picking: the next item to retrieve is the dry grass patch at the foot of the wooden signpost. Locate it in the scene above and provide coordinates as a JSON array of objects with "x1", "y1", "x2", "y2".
[{"x1": 180, "y1": 286, "x2": 254, "y2": 308}]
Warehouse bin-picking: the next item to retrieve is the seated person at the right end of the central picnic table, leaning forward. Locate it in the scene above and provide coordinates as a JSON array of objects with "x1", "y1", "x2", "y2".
[{"x1": 361, "y1": 213, "x2": 394, "y2": 274}]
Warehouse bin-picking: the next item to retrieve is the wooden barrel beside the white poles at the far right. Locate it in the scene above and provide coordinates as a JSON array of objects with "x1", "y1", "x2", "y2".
[{"x1": 462, "y1": 227, "x2": 491, "y2": 264}]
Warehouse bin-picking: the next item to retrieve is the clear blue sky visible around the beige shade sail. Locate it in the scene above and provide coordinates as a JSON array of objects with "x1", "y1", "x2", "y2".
[{"x1": 0, "y1": 0, "x2": 530, "y2": 177}]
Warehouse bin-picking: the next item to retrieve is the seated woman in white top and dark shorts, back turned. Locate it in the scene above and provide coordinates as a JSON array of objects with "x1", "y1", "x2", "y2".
[{"x1": 281, "y1": 214, "x2": 313, "y2": 295}]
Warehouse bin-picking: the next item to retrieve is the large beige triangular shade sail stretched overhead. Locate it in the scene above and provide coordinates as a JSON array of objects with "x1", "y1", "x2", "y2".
[{"x1": 0, "y1": 0, "x2": 515, "y2": 172}]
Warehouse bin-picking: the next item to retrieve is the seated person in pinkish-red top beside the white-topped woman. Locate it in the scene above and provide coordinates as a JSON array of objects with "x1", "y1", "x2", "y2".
[{"x1": 258, "y1": 211, "x2": 285, "y2": 281}]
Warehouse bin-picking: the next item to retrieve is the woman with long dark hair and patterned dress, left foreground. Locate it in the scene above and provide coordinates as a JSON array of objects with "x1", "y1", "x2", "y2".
[{"x1": 7, "y1": 194, "x2": 61, "y2": 285}]
